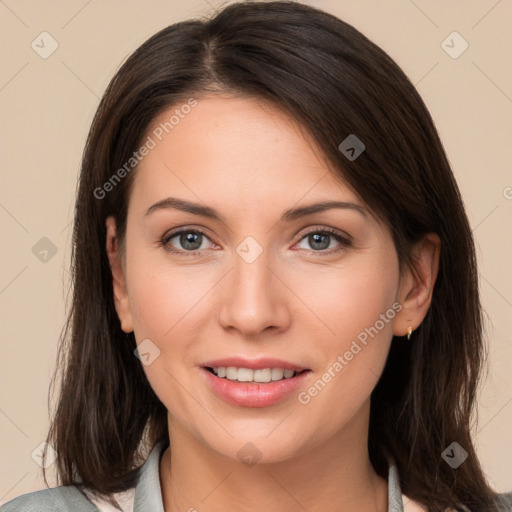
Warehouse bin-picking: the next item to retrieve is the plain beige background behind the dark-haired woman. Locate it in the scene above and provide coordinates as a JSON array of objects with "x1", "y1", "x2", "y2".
[{"x1": 0, "y1": 0, "x2": 512, "y2": 503}]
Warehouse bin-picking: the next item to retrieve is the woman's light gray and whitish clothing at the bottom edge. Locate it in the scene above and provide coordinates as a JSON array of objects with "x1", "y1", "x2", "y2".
[{"x1": 1, "y1": 440, "x2": 512, "y2": 512}]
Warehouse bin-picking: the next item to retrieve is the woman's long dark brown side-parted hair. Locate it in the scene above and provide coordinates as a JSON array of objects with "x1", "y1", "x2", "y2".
[{"x1": 45, "y1": 1, "x2": 504, "y2": 511}]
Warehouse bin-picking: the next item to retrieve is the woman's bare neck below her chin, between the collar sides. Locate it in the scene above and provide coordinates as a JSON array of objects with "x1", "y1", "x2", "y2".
[{"x1": 160, "y1": 406, "x2": 388, "y2": 512}]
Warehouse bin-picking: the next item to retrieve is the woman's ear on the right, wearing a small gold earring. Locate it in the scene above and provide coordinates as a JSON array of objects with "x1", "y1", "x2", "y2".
[{"x1": 393, "y1": 233, "x2": 441, "y2": 336}]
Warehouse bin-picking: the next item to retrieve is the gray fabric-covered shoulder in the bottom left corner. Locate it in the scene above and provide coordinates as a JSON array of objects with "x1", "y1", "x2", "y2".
[{"x1": 1, "y1": 486, "x2": 98, "y2": 512}]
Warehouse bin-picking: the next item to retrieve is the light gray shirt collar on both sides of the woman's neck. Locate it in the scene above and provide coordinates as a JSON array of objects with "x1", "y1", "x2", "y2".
[{"x1": 133, "y1": 440, "x2": 404, "y2": 512}]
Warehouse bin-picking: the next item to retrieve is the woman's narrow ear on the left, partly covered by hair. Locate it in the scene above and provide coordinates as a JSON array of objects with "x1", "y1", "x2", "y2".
[{"x1": 106, "y1": 217, "x2": 133, "y2": 333}]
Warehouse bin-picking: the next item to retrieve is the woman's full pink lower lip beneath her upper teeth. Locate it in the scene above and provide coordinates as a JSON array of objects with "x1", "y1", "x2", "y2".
[{"x1": 201, "y1": 368, "x2": 311, "y2": 407}]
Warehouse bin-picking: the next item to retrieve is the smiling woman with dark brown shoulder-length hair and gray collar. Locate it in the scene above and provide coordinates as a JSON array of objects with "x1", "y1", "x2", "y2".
[{"x1": 4, "y1": 2, "x2": 512, "y2": 512}]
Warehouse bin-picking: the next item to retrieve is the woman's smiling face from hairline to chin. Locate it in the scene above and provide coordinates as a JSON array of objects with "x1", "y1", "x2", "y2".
[{"x1": 110, "y1": 97, "x2": 403, "y2": 462}]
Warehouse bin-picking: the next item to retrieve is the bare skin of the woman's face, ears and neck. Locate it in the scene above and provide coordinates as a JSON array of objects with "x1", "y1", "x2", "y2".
[{"x1": 106, "y1": 96, "x2": 439, "y2": 512}]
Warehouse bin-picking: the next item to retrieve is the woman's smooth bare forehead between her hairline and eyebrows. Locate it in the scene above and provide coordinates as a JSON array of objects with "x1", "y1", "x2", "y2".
[{"x1": 133, "y1": 96, "x2": 356, "y2": 213}]
